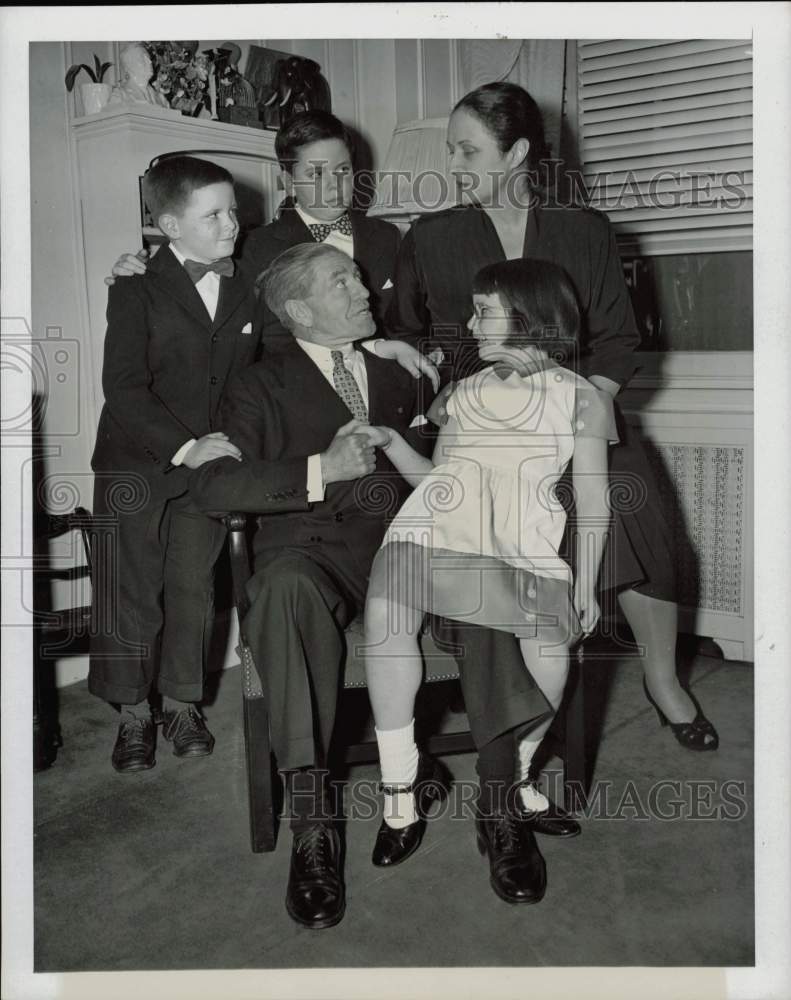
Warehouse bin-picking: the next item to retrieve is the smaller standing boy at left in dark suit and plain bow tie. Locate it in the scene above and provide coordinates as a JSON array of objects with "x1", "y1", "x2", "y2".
[{"x1": 89, "y1": 156, "x2": 258, "y2": 771}]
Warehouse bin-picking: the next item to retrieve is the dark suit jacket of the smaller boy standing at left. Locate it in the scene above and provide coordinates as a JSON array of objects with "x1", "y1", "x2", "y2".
[{"x1": 92, "y1": 247, "x2": 259, "y2": 499}]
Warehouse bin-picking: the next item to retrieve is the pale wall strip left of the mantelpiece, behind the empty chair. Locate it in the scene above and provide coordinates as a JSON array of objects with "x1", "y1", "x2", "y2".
[{"x1": 31, "y1": 42, "x2": 98, "y2": 683}]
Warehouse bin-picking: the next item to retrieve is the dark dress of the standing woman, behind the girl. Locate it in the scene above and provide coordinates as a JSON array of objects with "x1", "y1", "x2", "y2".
[{"x1": 387, "y1": 204, "x2": 675, "y2": 601}]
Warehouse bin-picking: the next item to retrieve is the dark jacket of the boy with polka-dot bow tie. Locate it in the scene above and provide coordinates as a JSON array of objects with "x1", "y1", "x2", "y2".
[{"x1": 234, "y1": 204, "x2": 400, "y2": 340}]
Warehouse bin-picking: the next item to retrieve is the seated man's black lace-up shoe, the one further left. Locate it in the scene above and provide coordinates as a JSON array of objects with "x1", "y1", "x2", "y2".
[{"x1": 286, "y1": 823, "x2": 346, "y2": 930}]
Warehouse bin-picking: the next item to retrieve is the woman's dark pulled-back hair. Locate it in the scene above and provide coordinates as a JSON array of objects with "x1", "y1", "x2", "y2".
[{"x1": 453, "y1": 83, "x2": 550, "y2": 174}]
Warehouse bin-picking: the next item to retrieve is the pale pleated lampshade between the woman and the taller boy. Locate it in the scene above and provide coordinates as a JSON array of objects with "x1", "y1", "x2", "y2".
[{"x1": 368, "y1": 118, "x2": 457, "y2": 220}]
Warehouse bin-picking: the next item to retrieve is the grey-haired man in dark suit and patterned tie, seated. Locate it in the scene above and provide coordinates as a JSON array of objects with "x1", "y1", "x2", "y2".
[{"x1": 191, "y1": 243, "x2": 568, "y2": 928}]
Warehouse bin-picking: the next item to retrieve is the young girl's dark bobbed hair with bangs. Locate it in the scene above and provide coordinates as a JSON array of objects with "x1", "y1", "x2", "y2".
[{"x1": 472, "y1": 257, "x2": 580, "y2": 354}]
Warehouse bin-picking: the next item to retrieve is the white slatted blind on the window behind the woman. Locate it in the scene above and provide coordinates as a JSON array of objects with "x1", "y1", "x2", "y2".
[{"x1": 577, "y1": 39, "x2": 753, "y2": 254}]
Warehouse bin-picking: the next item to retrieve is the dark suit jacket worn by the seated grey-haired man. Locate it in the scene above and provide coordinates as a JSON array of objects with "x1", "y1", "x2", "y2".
[{"x1": 191, "y1": 337, "x2": 431, "y2": 588}]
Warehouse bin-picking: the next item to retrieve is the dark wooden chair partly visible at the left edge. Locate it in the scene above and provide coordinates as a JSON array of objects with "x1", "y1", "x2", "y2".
[{"x1": 33, "y1": 507, "x2": 93, "y2": 771}]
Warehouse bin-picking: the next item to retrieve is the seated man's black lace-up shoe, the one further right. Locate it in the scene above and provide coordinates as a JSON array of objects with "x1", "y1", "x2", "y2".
[{"x1": 475, "y1": 812, "x2": 547, "y2": 903}]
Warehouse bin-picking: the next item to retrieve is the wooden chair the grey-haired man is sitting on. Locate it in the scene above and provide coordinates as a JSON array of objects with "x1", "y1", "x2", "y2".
[{"x1": 223, "y1": 513, "x2": 587, "y2": 852}]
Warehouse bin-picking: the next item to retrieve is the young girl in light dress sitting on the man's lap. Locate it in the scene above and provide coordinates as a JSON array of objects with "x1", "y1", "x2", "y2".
[{"x1": 365, "y1": 258, "x2": 617, "y2": 884}]
